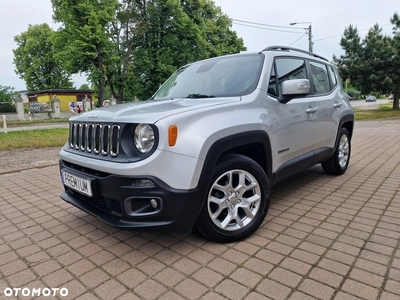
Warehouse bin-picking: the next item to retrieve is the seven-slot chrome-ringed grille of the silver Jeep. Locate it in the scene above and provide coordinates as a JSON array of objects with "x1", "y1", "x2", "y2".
[{"x1": 69, "y1": 122, "x2": 121, "y2": 157}]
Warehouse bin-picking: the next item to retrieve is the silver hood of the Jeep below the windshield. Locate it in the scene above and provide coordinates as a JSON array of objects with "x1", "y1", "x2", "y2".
[{"x1": 70, "y1": 97, "x2": 241, "y2": 124}]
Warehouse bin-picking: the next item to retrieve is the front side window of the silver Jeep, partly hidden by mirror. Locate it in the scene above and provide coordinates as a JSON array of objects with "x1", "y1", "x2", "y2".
[{"x1": 268, "y1": 58, "x2": 307, "y2": 96}]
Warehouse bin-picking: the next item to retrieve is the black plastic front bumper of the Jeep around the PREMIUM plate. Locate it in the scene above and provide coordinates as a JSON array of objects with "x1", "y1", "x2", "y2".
[{"x1": 60, "y1": 160, "x2": 204, "y2": 232}]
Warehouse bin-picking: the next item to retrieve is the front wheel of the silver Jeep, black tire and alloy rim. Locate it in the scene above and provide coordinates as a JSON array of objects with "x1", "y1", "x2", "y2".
[{"x1": 196, "y1": 154, "x2": 271, "y2": 243}]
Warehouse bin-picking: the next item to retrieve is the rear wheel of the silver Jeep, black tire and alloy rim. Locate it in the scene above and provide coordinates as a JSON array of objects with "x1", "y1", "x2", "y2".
[{"x1": 321, "y1": 127, "x2": 351, "y2": 175}]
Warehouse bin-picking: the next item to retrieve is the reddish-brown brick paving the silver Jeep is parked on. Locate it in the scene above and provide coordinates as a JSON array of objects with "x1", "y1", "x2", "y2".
[{"x1": 0, "y1": 120, "x2": 400, "y2": 300}]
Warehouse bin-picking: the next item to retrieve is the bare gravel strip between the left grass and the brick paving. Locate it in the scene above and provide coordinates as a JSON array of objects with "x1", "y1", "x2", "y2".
[{"x1": 0, "y1": 147, "x2": 61, "y2": 174}]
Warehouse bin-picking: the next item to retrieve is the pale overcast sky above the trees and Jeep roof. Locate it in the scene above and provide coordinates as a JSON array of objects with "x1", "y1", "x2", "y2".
[{"x1": 0, "y1": 0, "x2": 400, "y2": 91}]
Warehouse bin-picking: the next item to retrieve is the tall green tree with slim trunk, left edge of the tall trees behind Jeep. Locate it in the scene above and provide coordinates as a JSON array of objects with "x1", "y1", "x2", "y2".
[{"x1": 51, "y1": 0, "x2": 118, "y2": 103}]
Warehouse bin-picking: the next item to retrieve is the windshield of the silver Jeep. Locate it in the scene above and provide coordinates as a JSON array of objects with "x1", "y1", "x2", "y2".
[{"x1": 152, "y1": 54, "x2": 264, "y2": 99}]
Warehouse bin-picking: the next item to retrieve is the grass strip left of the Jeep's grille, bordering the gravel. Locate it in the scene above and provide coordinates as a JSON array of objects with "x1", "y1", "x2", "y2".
[{"x1": 0, "y1": 128, "x2": 68, "y2": 150}]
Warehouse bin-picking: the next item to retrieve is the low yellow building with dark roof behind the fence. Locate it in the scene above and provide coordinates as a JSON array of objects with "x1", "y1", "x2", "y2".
[{"x1": 27, "y1": 89, "x2": 94, "y2": 111}]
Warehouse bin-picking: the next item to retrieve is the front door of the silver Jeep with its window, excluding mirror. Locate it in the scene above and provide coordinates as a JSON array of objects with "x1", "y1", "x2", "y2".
[{"x1": 268, "y1": 57, "x2": 318, "y2": 171}]
